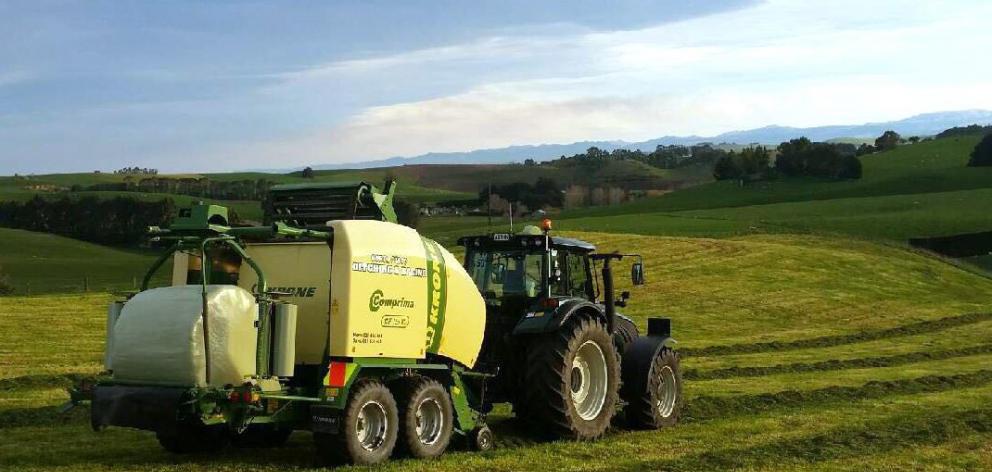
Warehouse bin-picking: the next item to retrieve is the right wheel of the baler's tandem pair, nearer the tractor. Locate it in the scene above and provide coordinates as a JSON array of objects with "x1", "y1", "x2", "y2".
[{"x1": 396, "y1": 377, "x2": 455, "y2": 459}]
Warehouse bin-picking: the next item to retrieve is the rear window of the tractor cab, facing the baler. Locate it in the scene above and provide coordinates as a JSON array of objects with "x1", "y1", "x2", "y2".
[{"x1": 467, "y1": 250, "x2": 545, "y2": 299}]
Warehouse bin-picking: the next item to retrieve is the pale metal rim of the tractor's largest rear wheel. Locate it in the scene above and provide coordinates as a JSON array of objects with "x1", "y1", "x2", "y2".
[{"x1": 569, "y1": 341, "x2": 608, "y2": 421}]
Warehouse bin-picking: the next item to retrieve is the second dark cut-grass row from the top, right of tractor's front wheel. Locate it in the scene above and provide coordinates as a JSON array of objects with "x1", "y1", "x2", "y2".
[{"x1": 682, "y1": 344, "x2": 992, "y2": 380}]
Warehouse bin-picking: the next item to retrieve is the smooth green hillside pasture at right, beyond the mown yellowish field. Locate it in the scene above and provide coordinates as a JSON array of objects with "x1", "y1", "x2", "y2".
[{"x1": 421, "y1": 132, "x2": 992, "y2": 243}]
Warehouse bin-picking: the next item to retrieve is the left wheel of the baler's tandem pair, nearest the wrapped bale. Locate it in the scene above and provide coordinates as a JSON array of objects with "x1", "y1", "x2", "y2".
[{"x1": 313, "y1": 380, "x2": 399, "y2": 465}]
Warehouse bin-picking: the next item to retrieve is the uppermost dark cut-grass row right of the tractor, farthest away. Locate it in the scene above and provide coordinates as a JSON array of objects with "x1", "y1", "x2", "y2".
[{"x1": 679, "y1": 313, "x2": 992, "y2": 357}]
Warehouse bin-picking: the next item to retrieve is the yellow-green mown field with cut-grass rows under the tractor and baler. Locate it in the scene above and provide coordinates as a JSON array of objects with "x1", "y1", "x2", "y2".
[{"x1": 0, "y1": 233, "x2": 992, "y2": 471}]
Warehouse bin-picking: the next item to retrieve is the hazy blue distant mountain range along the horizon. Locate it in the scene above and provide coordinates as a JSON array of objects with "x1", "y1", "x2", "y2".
[{"x1": 313, "y1": 110, "x2": 992, "y2": 169}]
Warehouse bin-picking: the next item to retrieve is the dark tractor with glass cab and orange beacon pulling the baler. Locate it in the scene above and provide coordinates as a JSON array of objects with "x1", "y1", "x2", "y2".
[{"x1": 459, "y1": 220, "x2": 683, "y2": 440}]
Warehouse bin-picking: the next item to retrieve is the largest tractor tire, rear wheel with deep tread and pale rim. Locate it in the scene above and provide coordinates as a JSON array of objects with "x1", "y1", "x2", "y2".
[{"x1": 518, "y1": 316, "x2": 620, "y2": 440}]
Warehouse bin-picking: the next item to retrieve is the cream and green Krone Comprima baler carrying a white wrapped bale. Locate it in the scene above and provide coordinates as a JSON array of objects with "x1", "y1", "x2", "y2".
[{"x1": 75, "y1": 205, "x2": 492, "y2": 463}]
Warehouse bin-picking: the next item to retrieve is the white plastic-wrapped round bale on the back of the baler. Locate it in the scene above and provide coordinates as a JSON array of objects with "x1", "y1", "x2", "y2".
[{"x1": 112, "y1": 285, "x2": 258, "y2": 387}]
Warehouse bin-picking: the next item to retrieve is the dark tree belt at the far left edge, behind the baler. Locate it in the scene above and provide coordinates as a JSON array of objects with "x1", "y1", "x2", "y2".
[{"x1": 0, "y1": 195, "x2": 176, "y2": 244}]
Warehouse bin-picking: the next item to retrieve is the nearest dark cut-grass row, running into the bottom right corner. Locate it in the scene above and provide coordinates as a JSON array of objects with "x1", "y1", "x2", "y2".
[{"x1": 624, "y1": 408, "x2": 992, "y2": 471}]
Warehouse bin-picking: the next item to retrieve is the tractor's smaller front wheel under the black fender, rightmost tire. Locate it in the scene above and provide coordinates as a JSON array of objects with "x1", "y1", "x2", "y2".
[{"x1": 624, "y1": 347, "x2": 684, "y2": 429}]
